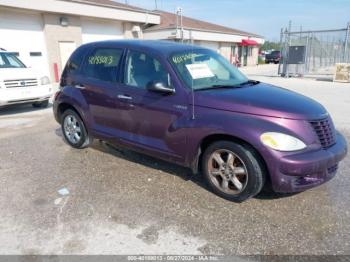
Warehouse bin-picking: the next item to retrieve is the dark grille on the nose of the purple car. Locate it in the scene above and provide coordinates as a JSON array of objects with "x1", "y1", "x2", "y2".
[{"x1": 310, "y1": 118, "x2": 336, "y2": 148}]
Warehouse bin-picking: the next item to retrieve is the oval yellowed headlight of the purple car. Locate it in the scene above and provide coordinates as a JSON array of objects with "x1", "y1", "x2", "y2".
[{"x1": 260, "y1": 132, "x2": 306, "y2": 151}]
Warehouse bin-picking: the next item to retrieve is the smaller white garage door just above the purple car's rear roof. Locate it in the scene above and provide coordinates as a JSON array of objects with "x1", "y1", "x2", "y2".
[{"x1": 82, "y1": 19, "x2": 124, "y2": 44}]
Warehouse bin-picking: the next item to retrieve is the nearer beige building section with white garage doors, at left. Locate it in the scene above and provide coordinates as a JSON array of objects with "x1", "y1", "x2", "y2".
[{"x1": 0, "y1": 0, "x2": 160, "y2": 81}]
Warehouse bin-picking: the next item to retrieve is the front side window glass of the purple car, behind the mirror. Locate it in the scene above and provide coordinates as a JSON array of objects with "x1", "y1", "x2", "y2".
[{"x1": 124, "y1": 51, "x2": 170, "y2": 89}]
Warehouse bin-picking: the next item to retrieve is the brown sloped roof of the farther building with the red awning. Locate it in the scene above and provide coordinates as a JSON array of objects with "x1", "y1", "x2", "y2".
[{"x1": 146, "y1": 10, "x2": 262, "y2": 38}]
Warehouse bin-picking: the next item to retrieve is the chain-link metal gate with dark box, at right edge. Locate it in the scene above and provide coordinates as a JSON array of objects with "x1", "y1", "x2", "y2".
[{"x1": 278, "y1": 23, "x2": 350, "y2": 77}]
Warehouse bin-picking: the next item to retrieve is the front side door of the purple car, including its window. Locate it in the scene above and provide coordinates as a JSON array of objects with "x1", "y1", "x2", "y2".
[{"x1": 120, "y1": 48, "x2": 189, "y2": 162}]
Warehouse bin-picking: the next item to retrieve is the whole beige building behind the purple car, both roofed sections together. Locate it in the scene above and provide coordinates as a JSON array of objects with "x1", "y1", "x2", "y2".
[{"x1": 0, "y1": 0, "x2": 264, "y2": 82}]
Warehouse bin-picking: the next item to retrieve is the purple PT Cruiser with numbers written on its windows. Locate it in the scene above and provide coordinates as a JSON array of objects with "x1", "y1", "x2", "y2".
[{"x1": 53, "y1": 40, "x2": 347, "y2": 202}]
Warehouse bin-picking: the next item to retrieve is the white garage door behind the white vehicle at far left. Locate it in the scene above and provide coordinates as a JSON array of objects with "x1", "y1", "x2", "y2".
[{"x1": 0, "y1": 10, "x2": 49, "y2": 75}]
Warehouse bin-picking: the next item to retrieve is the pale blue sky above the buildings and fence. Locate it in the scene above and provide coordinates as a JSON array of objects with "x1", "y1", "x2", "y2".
[{"x1": 117, "y1": 0, "x2": 350, "y2": 41}]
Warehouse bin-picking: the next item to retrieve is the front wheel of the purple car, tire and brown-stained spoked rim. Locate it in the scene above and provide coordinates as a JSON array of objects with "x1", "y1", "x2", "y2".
[{"x1": 201, "y1": 141, "x2": 266, "y2": 202}]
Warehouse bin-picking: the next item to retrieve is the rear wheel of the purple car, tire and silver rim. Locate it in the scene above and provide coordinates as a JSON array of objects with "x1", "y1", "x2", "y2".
[{"x1": 61, "y1": 109, "x2": 90, "y2": 149}]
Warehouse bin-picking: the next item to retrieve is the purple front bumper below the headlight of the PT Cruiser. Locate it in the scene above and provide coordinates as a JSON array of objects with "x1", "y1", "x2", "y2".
[{"x1": 271, "y1": 133, "x2": 347, "y2": 193}]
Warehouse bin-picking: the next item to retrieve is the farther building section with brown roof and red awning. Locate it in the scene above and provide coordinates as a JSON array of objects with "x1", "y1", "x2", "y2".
[{"x1": 144, "y1": 11, "x2": 264, "y2": 66}]
